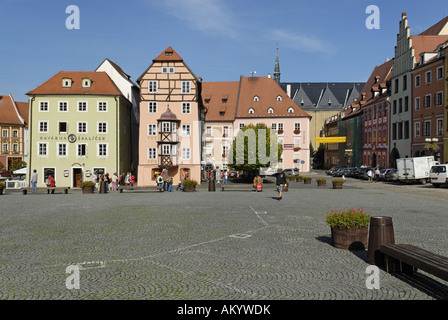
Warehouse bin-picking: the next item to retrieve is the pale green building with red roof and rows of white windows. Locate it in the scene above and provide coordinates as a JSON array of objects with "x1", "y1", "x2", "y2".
[{"x1": 27, "y1": 71, "x2": 131, "y2": 188}]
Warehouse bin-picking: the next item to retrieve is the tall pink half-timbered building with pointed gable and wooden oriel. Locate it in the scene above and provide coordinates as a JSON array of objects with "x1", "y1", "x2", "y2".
[{"x1": 137, "y1": 47, "x2": 204, "y2": 186}]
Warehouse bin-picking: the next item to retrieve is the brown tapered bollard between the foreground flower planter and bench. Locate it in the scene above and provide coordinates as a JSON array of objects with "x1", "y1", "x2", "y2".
[{"x1": 367, "y1": 217, "x2": 395, "y2": 267}]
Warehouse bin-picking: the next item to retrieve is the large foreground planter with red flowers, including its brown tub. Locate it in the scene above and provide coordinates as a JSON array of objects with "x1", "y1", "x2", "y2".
[{"x1": 326, "y1": 208, "x2": 370, "y2": 250}]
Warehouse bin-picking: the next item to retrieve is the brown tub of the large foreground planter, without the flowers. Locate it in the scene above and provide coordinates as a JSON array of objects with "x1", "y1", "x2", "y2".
[{"x1": 331, "y1": 227, "x2": 369, "y2": 250}]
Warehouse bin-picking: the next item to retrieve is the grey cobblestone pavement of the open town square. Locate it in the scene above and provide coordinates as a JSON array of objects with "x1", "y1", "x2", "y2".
[{"x1": 0, "y1": 172, "x2": 448, "y2": 300}]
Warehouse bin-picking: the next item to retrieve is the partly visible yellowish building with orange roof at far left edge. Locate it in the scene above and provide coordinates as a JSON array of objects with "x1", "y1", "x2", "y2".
[{"x1": 0, "y1": 94, "x2": 28, "y2": 171}]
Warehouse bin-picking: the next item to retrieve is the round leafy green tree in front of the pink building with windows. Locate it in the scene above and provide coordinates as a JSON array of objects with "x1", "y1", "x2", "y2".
[{"x1": 228, "y1": 123, "x2": 283, "y2": 172}]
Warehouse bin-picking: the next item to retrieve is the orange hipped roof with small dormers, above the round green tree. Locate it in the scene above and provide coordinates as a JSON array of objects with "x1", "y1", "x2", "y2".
[{"x1": 236, "y1": 77, "x2": 310, "y2": 118}]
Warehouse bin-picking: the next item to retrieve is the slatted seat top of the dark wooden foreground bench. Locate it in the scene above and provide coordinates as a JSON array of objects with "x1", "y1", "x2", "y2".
[{"x1": 380, "y1": 244, "x2": 448, "y2": 280}]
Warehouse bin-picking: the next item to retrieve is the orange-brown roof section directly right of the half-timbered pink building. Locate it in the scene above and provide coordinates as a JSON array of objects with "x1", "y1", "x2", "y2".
[{"x1": 202, "y1": 81, "x2": 240, "y2": 121}]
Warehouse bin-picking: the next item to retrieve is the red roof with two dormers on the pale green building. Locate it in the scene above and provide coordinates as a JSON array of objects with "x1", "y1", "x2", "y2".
[{"x1": 27, "y1": 71, "x2": 121, "y2": 96}]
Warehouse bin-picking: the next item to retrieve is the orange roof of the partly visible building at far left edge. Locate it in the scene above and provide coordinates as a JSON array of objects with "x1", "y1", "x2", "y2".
[{"x1": 0, "y1": 94, "x2": 29, "y2": 125}]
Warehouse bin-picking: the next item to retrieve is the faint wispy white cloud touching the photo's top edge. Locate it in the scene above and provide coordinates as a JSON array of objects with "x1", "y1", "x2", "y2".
[{"x1": 152, "y1": 0, "x2": 238, "y2": 38}]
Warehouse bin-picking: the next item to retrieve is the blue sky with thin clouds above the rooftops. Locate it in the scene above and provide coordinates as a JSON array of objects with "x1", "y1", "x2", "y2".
[{"x1": 0, "y1": 0, "x2": 448, "y2": 101}]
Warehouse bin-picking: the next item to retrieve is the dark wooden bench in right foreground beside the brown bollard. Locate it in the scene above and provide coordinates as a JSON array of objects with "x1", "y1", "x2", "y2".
[{"x1": 380, "y1": 244, "x2": 448, "y2": 281}]
